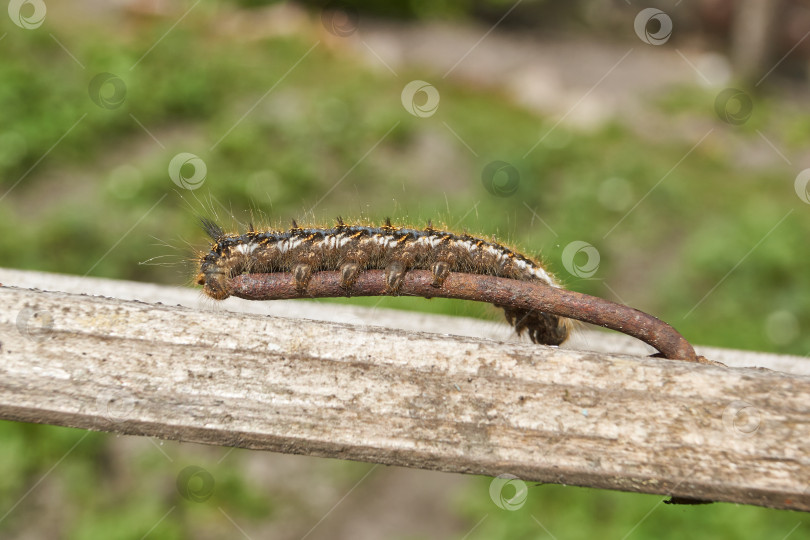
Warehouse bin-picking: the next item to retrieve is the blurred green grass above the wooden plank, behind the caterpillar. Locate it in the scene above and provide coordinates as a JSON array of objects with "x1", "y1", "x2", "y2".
[{"x1": 0, "y1": 22, "x2": 810, "y2": 354}]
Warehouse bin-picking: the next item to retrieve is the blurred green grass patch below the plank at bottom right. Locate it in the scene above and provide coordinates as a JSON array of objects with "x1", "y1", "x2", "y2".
[{"x1": 459, "y1": 478, "x2": 810, "y2": 540}]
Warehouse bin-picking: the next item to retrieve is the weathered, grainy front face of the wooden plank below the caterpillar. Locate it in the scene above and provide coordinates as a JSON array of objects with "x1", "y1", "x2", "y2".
[{"x1": 0, "y1": 280, "x2": 810, "y2": 511}]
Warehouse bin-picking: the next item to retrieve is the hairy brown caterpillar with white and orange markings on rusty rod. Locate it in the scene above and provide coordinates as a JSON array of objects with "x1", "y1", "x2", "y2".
[{"x1": 195, "y1": 218, "x2": 572, "y2": 345}]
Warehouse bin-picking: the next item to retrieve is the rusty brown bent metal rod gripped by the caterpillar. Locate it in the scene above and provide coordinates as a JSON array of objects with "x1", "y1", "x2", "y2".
[{"x1": 229, "y1": 270, "x2": 714, "y2": 364}]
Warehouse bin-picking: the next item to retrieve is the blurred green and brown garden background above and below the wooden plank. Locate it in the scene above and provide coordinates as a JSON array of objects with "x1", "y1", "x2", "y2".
[{"x1": 0, "y1": 0, "x2": 810, "y2": 539}]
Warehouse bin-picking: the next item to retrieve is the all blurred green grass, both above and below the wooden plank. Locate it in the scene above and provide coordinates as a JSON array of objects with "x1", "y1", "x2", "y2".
[{"x1": 0, "y1": 4, "x2": 810, "y2": 539}]
